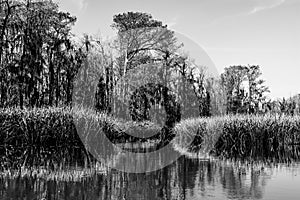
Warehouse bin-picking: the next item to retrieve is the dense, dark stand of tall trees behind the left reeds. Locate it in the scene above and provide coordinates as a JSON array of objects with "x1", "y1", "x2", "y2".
[{"x1": 0, "y1": 0, "x2": 84, "y2": 108}]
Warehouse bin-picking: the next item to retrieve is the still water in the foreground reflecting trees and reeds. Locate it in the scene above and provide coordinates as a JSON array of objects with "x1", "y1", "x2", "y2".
[{"x1": 0, "y1": 156, "x2": 300, "y2": 200}]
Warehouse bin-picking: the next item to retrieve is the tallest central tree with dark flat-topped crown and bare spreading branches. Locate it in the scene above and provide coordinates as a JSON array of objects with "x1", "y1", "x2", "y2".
[{"x1": 112, "y1": 12, "x2": 177, "y2": 115}]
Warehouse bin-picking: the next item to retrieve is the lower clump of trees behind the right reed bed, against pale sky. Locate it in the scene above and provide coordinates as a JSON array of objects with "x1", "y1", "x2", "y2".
[{"x1": 221, "y1": 65, "x2": 300, "y2": 115}]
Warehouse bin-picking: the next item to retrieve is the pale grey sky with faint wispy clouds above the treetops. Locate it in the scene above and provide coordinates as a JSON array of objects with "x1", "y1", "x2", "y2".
[{"x1": 59, "y1": 0, "x2": 300, "y2": 99}]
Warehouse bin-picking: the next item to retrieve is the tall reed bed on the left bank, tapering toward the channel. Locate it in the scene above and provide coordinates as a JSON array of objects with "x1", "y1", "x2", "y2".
[{"x1": 0, "y1": 107, "x2": 160, "y2": 171}]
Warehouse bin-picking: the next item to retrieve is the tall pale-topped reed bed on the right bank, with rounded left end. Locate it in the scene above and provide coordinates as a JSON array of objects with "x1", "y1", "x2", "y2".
[{"x1": 174, "y1": 115, "x2": 300, "y2": 161}]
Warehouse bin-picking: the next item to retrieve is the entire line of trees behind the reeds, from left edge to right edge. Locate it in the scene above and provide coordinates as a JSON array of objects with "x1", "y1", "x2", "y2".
[{"x1": 0, "y1": 0, "x2": 299, "y2": 117}]
